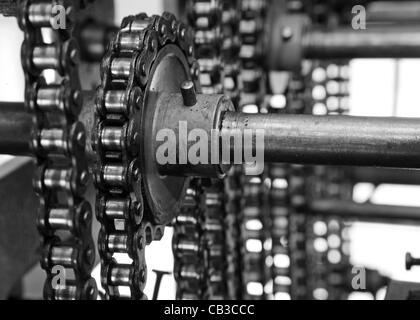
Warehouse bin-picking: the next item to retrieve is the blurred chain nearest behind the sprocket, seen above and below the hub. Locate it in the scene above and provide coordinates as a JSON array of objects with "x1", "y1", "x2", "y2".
[{"x1": 177, "y1": 0, "x2": 222, "y2": 300}]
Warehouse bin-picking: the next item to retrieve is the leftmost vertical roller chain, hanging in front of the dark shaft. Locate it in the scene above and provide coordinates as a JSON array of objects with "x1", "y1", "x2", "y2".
[{"x1": 18, "y1": 0, "x2": 97, "y2": 300}]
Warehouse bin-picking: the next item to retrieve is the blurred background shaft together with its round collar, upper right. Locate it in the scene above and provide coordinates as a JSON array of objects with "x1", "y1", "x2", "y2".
[{"x1": 267, "y1": 15, "x2": 420, "y2": 71}]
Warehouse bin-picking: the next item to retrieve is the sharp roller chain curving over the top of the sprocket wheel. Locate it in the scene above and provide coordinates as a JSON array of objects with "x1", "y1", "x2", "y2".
[{"x1": 92, "y1": 13, "x2": 197, "y2": 299}]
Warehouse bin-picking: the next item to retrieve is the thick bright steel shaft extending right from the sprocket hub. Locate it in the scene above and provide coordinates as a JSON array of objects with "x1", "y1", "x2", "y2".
[{"x1": 222, "y1": 112, "x2": 420, "y2": 168}]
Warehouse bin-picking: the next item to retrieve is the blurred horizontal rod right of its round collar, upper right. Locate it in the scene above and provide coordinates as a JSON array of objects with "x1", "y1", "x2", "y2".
[{"x1": 302, "y1": 25, "x2": 420, "y2": 59}]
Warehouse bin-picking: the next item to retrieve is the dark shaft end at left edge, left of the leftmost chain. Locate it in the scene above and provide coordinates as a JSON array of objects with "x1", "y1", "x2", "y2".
[{"x1": 0, "y1": 102, "x2": 32, "y2": 156}]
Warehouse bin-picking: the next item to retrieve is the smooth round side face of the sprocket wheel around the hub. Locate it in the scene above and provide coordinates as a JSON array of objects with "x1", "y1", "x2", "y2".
[{"x1": 141, "y1": 45, "x2": 198, "y2": 224}]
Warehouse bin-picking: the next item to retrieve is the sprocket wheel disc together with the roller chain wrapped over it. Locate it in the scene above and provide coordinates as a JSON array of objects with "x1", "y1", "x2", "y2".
[{"x1": 92, "y1": 13, "x2": 198, "y2": 299}]
